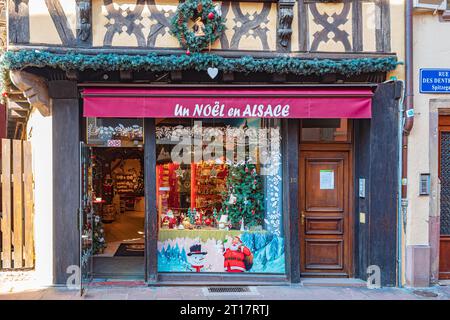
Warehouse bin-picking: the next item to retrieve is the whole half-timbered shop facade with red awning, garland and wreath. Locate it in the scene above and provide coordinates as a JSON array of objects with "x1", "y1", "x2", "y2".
[{"x1": 4, "y1": 0, "x2": 404, "y2": 286}]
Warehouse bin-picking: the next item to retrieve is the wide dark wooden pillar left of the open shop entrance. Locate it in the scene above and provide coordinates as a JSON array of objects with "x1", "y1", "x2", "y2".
[{"x1": 49, "y1": 81, "x2": 80, "y2": 284}]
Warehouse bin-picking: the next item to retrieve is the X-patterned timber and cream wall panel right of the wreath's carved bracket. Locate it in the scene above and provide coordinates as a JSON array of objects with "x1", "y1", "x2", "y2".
[{"x1": 298, "y1": 0, "x2": 391, "y2": 52}]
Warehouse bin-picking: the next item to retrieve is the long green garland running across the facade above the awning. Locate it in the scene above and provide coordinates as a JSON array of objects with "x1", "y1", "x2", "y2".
[{"x1": 0, "y1": 50, "x2": 401, "y2": 98}]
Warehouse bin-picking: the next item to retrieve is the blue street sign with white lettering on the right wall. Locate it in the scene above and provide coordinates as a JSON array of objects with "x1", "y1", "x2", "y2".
[{"x1": 420, "y1": 69, "x2": 450, "y2": 93}]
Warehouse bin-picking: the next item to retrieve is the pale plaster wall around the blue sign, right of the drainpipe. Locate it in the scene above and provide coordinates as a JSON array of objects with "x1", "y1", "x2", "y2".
[{"x1": 406, "y1": 11, "x2": 450, "y2": 286}]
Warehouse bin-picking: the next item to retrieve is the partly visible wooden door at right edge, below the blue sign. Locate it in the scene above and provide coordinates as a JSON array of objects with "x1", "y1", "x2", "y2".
[{"x1": 439, "y1": 116, "x2": 450, "y2": 279}]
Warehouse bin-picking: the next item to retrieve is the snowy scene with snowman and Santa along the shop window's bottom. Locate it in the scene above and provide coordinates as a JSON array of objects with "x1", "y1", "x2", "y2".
[{"x1": 158, "y1": 232, "x2": 285, "y2": 273}]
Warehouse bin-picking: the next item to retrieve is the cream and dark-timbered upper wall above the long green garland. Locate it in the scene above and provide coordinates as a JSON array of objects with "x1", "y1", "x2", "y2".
[{"x1": 9, "y1": 0, "x2": 398, "y2": 53}]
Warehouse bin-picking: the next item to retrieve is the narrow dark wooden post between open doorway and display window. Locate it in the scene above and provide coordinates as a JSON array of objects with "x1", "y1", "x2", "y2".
[{"x1": 144, "y1": 118, "x2": 158, "y2": 284}]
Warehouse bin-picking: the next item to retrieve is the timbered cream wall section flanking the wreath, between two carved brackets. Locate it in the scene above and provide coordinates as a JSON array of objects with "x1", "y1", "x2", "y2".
[{"x1": 94, "y1": 0, "x2": 277, "y2": 50}]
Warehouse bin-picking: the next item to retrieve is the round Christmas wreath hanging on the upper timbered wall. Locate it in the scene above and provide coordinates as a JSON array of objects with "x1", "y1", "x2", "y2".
[{"x1": 171, "y1": 0, "x2": 225, "y2": 54}]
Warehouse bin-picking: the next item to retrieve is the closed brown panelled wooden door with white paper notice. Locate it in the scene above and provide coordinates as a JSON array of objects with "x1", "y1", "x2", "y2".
[{"x1": 299, "y1": 151, "x2": 351, "y2": 277}]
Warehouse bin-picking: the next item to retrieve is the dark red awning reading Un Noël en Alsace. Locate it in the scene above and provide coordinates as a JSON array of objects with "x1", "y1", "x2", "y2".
[{"x1": 83, "y1": 87, "x2": 373, "y2": 118}]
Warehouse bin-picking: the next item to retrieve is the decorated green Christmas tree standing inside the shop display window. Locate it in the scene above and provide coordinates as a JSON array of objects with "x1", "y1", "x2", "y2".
[{"x1": 223, "y1": 164, "x2": 264, "y2": 229}]
